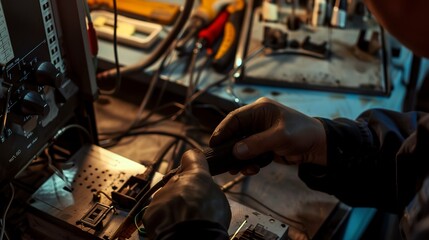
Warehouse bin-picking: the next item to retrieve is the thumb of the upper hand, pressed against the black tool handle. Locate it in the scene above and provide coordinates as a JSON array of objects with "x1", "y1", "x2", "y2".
[{"x1": 233, "y1": 129, "x2": 276, "y2": 159}]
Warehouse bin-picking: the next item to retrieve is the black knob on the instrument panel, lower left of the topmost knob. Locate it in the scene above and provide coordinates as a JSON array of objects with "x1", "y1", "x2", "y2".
[{"x1": 20, "y1": 90, "x2": 50, "y2": 117}]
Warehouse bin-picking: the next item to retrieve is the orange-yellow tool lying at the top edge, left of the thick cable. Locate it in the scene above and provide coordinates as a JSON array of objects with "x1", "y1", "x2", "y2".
[{"x1": 87, "y1": 0, "x2": 180, "y2": 25}]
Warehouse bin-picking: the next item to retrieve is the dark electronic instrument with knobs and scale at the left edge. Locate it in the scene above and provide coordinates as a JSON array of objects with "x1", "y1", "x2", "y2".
[{"x1": 0, "y1": 0, "x2": 98, "y2": 190}]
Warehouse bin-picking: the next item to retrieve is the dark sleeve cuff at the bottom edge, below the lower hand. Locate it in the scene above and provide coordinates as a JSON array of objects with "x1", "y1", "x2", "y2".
[{"x1": 156, "y1": 220, "x2": 229, "y2": 240}]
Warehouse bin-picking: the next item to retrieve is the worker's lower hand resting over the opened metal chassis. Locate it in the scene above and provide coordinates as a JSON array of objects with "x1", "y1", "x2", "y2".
[{"x1": 143, "y1": 150, "x2": 231, "y2": 239}]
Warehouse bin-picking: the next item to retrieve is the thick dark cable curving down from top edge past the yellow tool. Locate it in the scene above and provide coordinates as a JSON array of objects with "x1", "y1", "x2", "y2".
[{"x1": 97, "y1": 0, "x2": 194, "y2": 78}]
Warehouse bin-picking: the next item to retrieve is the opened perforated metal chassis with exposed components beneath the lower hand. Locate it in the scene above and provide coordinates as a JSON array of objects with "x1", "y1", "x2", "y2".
[{"x1": 25, "y1": 145, "x2": 288, "y2": 240}]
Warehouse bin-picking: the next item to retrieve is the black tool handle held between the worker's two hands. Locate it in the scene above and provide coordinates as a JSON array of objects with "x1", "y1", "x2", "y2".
[{"x1": 203, "y1": 141, "x2": 274, "y2": 176}]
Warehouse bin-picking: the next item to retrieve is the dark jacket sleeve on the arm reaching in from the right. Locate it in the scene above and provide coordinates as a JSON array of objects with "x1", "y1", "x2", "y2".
[{"x1": 298, "y1": 109, "x2": 429, "y2": 213}]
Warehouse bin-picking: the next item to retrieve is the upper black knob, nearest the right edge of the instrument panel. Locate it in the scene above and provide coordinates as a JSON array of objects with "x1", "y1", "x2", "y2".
[{"x1": 35, "y1": 62, "x2": 64, "y2": 88}]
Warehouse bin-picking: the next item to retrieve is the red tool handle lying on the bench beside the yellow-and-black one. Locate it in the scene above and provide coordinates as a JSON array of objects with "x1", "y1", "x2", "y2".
[{"x1": 198, "y1": 10, "x2": 229, "y2": 47}]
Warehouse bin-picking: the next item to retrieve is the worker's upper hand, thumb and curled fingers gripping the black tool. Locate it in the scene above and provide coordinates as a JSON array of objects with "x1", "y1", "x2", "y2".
[{"x1": 210, "y1": 98, "x2": 327, "y2": 175}]
